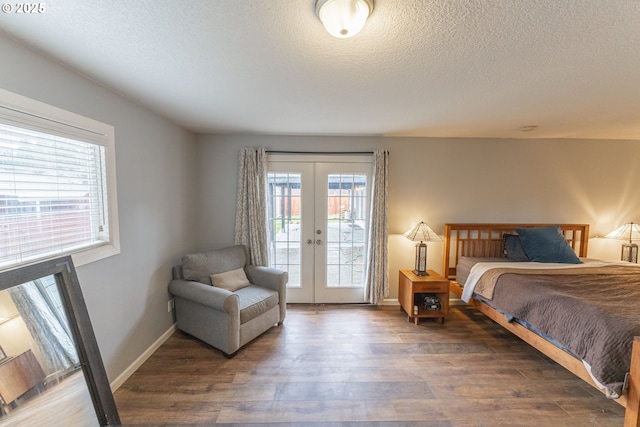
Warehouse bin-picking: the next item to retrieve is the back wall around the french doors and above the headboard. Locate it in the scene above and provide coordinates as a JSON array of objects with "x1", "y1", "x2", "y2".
[{"x1": 198, "y1": 135, "x2": 640, "y2": 299}]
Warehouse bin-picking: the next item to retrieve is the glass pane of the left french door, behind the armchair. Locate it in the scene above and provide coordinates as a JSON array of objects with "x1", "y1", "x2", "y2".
[{"x1": 267, "y1": 172, "x2": 302, "y2": 288}]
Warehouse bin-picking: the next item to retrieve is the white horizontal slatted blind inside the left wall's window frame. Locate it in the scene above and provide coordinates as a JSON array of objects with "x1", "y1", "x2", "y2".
[{"x1": 0, "y1": 123, "x2": 109, "y2": 266}]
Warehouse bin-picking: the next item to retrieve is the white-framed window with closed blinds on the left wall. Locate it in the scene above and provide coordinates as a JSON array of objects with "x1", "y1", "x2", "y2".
[{"x1": 0, "y1": 91, "x2": 119, "y2": 269}]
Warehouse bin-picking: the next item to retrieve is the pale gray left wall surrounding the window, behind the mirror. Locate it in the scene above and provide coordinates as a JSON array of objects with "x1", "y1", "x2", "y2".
[{"x1": 0, "y1": 36, "x2": 197, "y2": 381}]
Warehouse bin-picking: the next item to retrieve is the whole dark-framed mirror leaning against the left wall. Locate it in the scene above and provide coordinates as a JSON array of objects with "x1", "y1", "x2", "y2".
[{"x1": 0, "y1": 257, "x2": 120, "y2": 426}]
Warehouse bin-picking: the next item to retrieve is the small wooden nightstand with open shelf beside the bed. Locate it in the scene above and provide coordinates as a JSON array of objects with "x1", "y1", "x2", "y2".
[{"x1": 398, "y1": 270, "x2": 449, "y2": 325}]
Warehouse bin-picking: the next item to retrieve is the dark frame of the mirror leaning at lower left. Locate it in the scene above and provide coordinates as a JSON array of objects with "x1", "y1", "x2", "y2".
[{"x1": 0, "y1": 256, "x2": 120, "y2": 426}]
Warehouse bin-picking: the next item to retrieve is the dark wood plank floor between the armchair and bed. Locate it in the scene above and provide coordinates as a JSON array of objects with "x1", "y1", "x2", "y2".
[{"x1": 115, "y1": 305, "x2": 624, "y2": 427}]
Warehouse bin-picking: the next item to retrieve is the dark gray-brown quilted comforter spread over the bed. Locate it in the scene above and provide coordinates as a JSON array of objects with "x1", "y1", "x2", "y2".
[{"x1": 485, "y1": 266, "x2": 640, "y2": 398}]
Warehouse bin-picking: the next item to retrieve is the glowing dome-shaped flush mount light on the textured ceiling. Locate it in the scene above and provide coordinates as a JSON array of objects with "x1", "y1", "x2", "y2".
[{"x1": 316, "y1": 0, "x2": 373, "y2": 39}]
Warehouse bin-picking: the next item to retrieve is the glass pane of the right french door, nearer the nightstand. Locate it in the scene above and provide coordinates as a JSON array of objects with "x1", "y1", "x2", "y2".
[{"x1": 327, "y1": 174, "x2": 367, "y2": 288}]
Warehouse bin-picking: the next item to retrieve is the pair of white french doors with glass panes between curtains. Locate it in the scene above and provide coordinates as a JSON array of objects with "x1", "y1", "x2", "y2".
[{"x1": 267, "y1": 155, "x2": 371, "y2": 303}]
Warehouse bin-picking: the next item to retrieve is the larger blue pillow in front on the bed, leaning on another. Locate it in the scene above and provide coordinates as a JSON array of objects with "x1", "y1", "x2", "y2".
[{"x1": 516, "y1": 225, "x2": 582, "y2": 264}]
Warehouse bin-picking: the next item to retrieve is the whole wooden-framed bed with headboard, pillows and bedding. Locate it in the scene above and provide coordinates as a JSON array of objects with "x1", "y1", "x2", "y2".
[{"x1": 442, "y1": 223, "x2": 640, "y2": 426}]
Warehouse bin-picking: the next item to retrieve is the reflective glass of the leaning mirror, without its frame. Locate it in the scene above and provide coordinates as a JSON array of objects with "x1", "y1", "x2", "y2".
[{"x1": 0, "y1": 275, "x2": 99, "y2": 426}]
